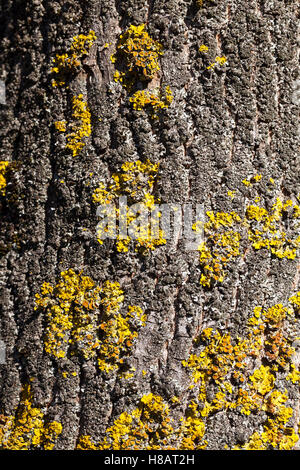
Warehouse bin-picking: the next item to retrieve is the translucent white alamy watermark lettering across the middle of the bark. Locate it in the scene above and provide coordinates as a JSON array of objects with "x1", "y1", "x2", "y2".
[{"x1": 96, "y1": 196, "x2": 205, "y2": 251}]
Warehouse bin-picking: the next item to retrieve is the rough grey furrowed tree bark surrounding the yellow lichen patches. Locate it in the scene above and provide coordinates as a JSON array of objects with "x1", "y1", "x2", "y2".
[{"x1": 0, "y1": 0, "x2": 300, "y2": 449}]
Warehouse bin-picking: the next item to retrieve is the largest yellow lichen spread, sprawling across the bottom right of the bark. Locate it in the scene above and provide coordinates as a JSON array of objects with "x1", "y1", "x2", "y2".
[{"x1": 78, "y1": 292, "x2": 298, "y2": 450}]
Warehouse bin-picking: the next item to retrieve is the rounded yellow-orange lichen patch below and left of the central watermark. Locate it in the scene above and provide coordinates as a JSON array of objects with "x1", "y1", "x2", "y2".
[{"x1": 35, "y1": 269, "x2": 146, "y2": 372}]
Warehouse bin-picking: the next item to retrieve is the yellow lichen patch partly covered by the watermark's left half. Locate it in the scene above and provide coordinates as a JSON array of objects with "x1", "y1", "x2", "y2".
[{"x1": 93, "y1": 160, "x2": 166, "y2": 253}]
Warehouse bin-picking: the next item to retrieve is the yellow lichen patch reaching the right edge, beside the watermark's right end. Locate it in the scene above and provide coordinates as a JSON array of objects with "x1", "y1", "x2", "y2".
[{"x1": 198, "y1": 184, "x2": 300, "y2": 288}]
